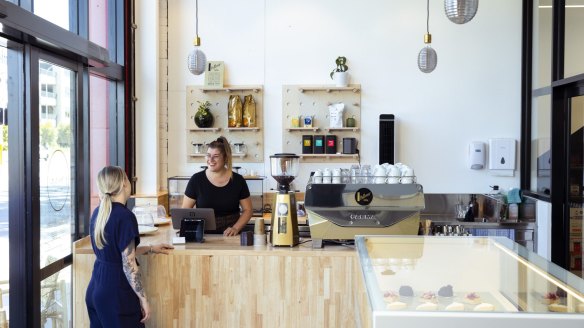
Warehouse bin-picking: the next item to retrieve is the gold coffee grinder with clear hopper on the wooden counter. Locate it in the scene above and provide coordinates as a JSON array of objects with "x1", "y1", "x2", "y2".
[{"x1": 270, "y1": 154, "x2": 300, "y2": 247}]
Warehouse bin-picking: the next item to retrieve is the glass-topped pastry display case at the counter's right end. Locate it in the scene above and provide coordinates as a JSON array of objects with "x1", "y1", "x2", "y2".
[{"x1": 355, "y1": 236, "x2": 584, "y2": 328}]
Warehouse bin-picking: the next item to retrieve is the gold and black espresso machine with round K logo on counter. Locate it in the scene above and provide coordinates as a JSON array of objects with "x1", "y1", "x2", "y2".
[{"x1": 304, "y1": 177, "x2": 425, "y2": 248}]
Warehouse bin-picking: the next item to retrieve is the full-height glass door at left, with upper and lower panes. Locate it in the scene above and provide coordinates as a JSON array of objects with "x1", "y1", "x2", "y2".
[{"x1": 38, "y1": 53, "x2": 80, "y2": 327}]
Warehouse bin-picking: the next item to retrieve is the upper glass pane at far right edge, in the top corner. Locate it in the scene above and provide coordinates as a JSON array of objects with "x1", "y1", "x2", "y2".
[{"x1": 564, "y1": 0, "x2": 584, "y2": 78}]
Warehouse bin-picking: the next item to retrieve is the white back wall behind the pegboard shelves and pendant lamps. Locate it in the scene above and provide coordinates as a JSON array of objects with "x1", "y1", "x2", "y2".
[{"x1": 137, "y1": 0, "x2": 522, "y2": 193}]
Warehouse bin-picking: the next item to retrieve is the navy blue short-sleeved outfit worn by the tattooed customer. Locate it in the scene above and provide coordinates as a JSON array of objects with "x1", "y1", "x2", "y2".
[{"x1": 85, "y1": 203, "x2": 144, "y2": 328}]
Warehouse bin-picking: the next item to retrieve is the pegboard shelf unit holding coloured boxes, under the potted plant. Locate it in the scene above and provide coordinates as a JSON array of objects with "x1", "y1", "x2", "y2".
[{"x1": 282, "y1": 84, "x2": 361, "y2": 163}]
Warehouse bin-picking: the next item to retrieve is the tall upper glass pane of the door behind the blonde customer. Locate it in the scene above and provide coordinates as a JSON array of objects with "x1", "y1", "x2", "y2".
[{"x1": 39, "y1": 61, "x2": 77, "y2": 268}]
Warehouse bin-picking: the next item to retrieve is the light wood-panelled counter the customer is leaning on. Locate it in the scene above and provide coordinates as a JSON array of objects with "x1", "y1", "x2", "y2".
[{"x1": 73, "y1": 225, "x2": 363, "y2": 327}]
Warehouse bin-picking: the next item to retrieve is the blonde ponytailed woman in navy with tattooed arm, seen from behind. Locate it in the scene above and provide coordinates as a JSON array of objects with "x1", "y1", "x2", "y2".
[{"x1": 85, "y1": 166, "x2": 173, "y2": 327}]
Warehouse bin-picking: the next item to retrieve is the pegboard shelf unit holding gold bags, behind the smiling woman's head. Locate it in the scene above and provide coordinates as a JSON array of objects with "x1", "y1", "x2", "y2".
[{"x1": 185, "y1": 85, "x2": 264, "y2": 163}]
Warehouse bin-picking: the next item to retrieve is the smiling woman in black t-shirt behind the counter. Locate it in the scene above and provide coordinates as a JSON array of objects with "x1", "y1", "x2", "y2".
[{"x1": 182, "y1": 137, "x2": 253, "y2": 236}]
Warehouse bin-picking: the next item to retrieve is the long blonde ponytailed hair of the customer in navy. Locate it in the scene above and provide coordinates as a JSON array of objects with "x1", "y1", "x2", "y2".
[{"x1": 93, "y1": 166, "x2": 126, "y2": 249}]
